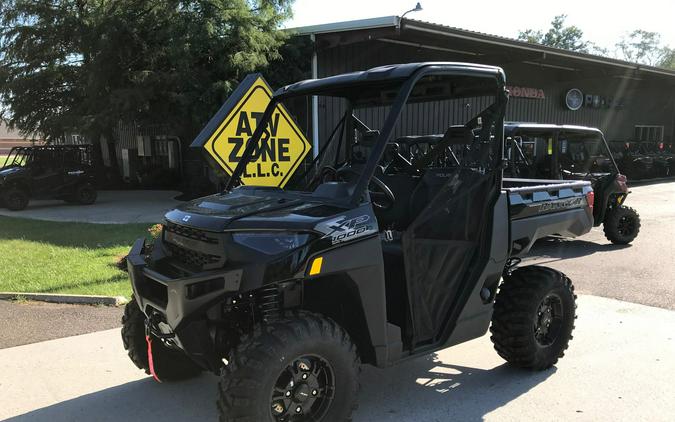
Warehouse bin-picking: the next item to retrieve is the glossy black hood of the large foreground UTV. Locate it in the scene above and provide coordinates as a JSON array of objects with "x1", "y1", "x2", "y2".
[{"x1": 166, "y1": 189, "x2": 344, "y2": 232}]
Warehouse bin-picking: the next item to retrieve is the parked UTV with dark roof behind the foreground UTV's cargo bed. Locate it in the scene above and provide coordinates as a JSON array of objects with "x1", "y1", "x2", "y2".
[{"x1": 504, "y1": 123, "x2": 640, "y2": 244}]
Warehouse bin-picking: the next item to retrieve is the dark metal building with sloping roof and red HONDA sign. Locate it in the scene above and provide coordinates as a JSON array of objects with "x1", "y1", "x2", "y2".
[{"x1": 292, "y1": 16, "x2": 675, "y2": 150}]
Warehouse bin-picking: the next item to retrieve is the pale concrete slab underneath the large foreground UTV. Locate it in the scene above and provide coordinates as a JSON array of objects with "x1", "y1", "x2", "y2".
[{"x1": 0, "y1": 296, "x2": 675, "y2": 422}]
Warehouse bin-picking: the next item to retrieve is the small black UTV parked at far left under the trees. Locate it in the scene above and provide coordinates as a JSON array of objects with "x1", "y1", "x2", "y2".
[{"x1": 0, "y1": 145, "x2": 97, "y2": 211}]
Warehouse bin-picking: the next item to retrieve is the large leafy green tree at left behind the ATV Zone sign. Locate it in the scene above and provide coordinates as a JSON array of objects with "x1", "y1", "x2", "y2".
[{"x1": 0, "y1": 0, "x2": 292, "y2": 139}]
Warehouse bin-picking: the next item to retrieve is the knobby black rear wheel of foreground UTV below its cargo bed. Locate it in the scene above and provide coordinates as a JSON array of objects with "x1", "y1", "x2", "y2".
[{"x1": 490, "y1": 266, "x2": 576, "y2": 370}]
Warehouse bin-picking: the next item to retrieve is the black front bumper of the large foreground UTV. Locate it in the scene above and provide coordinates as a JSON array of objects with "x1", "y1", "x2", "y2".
[{"x1": 127, "y1": 238, "x2": 243, "y2": 351}]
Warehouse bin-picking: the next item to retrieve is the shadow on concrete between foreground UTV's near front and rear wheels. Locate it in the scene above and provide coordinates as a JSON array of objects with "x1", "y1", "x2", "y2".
[{"x1": 354, "y1": 354, "x2": 556, "y2": 422}]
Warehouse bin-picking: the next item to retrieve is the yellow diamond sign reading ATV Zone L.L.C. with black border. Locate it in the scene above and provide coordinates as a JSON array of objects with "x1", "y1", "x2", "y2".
[{"x1": 192, "y1": 74, "x2": 311, "y2": 187}]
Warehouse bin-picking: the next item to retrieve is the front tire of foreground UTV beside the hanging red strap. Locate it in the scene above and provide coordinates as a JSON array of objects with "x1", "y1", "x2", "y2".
[{"x1": 122, "y1": 296, "x2": 202, "y2": 381}]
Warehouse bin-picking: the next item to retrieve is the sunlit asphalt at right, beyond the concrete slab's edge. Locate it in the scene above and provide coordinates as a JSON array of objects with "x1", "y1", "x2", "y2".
[{"x1": 523, "y1": 181, "x2": 675, "y2": 310}]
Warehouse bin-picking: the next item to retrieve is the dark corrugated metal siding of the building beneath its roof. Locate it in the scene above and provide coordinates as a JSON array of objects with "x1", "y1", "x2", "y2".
[{"x1": 314, "y1": 41, "x2": 675, "y2": 145}]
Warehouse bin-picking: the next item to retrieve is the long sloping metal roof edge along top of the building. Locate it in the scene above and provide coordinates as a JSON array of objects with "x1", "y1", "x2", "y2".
[{"x1": 288, "y1": 16, "x2": 675, "y2": 77}]
